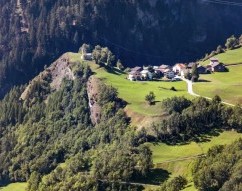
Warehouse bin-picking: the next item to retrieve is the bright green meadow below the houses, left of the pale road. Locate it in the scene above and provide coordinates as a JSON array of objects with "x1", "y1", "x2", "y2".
[{"x1": 69, "y1": 53, "x2": 189, "y2": 117}]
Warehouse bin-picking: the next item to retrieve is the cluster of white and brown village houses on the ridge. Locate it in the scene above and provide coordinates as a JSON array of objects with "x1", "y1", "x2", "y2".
[{"x1": 128, "y1": 58, "x2": 226, "y2": 81}]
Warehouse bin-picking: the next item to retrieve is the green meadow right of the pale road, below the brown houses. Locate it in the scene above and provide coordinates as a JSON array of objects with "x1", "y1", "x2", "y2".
[{"x1": 193, "y1": 64, "x2": 242, "y2": 104}]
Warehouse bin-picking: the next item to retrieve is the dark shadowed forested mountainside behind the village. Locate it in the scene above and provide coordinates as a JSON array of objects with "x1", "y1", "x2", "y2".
[{"x1": 0, "y1": 0, "x2": 242, "y2": 95}]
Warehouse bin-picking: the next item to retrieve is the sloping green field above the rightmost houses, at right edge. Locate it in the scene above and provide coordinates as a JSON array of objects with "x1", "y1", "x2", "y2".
[{"x1": 200, "y1": 48, "x2": 242, "y2": 65}]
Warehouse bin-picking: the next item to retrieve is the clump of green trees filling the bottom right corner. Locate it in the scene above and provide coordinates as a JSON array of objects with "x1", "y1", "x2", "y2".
[{"x1": 193, "y1": 139, "x2": 242, "y2": 191}]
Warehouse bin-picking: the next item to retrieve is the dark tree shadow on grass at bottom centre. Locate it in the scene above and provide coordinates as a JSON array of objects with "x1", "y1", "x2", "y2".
[{"x1": 133, "y1": 168, "x2": 170, "y2": 185}]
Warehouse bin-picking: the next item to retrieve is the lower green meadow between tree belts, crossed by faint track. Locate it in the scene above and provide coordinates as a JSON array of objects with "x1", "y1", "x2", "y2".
[{"x1": 149, "y1": 131, "x2": 242, "y2": 191}]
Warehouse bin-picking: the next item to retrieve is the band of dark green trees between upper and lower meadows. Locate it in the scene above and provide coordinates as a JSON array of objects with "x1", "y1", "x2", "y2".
[{"x1": 151, "y1": 96, "x2": 242, "y2": 144}]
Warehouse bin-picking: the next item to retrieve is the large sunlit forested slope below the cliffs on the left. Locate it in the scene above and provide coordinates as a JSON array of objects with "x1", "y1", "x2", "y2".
[{"x1": 0, "y1": 57, "x2": 153, "y2": 191}]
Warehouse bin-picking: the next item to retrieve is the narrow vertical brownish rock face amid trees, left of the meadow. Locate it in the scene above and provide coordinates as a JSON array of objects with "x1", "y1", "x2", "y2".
[{"x1": 87, "y1": 76, "x2": 101, "y2": 125}]
